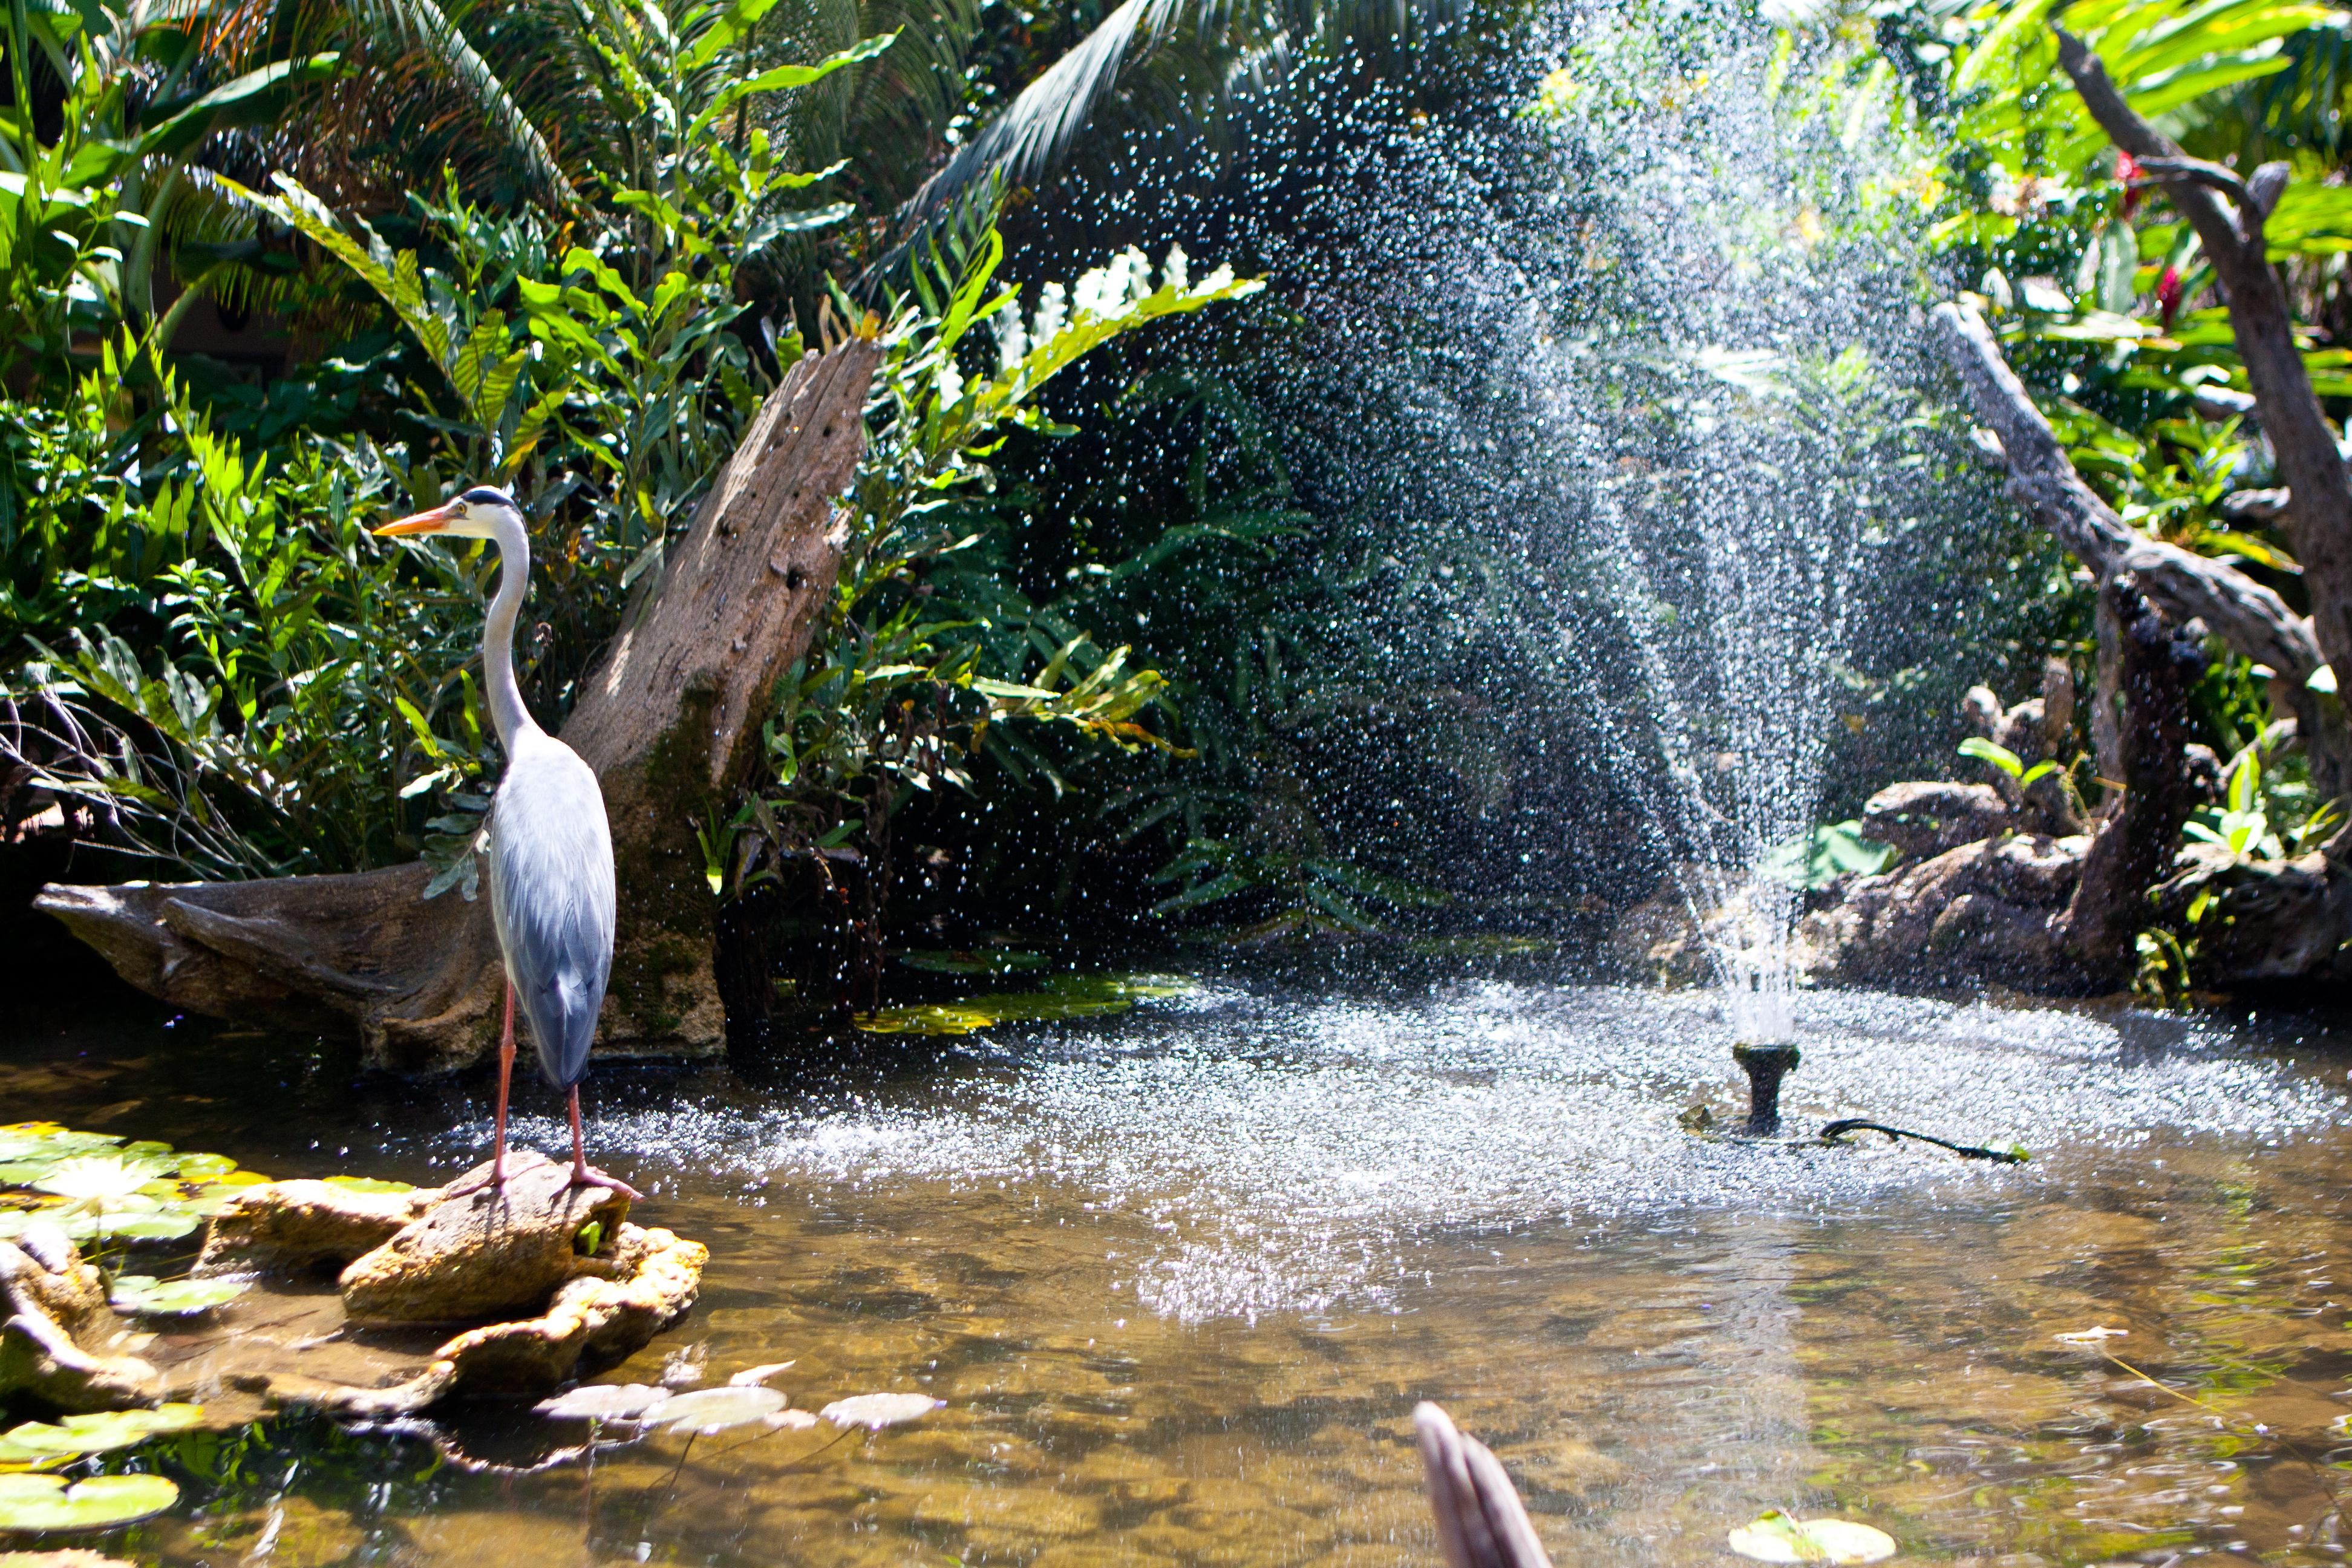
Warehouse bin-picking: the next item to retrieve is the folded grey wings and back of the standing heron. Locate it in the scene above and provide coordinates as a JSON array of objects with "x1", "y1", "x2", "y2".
[{"x1": 489, "y1": 733, "x2": 614, "y2": 1088}]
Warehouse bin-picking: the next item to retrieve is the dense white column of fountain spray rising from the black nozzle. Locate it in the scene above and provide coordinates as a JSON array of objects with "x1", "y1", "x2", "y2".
[{"x1": 1545, "y1": 10, "x2": 1919, "y2": 1135}]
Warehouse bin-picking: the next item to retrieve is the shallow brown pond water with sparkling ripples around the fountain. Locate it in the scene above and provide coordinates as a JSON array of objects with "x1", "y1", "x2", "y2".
[{"x1": 13, "y1": 980, "x2": 2352, "y2": 1568}]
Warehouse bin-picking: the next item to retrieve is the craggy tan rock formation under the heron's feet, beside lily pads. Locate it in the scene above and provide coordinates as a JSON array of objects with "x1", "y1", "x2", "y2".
[{"x1": 0, "y1": 1154, "x2": 710, "y2": 1417}]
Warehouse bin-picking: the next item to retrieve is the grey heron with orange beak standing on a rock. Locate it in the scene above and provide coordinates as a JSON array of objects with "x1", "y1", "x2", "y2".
[{"x1": 376, "y1": 485, "x2": 638, "y2": 1197}]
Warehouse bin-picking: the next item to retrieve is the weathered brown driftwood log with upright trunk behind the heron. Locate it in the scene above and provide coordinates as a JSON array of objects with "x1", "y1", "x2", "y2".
[{"x1": 38, "y1": 339, "x2": 880, "y2": 1072}]
